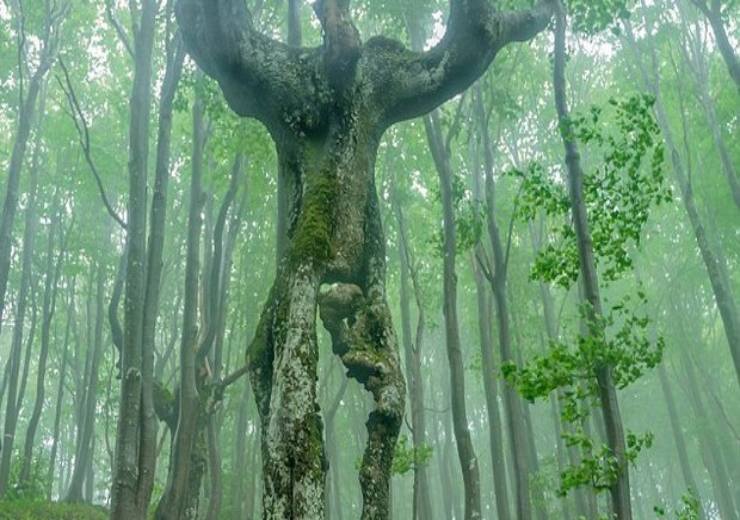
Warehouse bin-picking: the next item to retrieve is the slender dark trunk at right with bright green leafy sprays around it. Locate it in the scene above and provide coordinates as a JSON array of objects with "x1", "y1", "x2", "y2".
[{"x1": 553, "y1": 0, "x2": 632, "y2": 520}]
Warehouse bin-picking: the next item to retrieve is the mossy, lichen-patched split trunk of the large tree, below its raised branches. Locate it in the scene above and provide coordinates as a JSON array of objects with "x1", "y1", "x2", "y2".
[{"x1": 248, "y1": 110, "x2": 405, "y2": 519}]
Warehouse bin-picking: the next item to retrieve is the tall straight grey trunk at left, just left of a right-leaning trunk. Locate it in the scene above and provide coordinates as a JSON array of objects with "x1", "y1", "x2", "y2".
[{"x1": 111, "y1": 0, "x2": 158, "y2": 520}]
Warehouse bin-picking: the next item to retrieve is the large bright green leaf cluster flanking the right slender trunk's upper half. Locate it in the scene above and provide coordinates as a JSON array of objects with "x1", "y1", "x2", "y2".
[{"x1": 509, "y1": 95, "x2": 672, "y2": 288}]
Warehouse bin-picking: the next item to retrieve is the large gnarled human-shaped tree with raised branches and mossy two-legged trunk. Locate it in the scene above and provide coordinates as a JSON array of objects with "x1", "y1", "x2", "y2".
[{"x1": 177, "y1": 0, "x2": 552, "y2": 520}]
